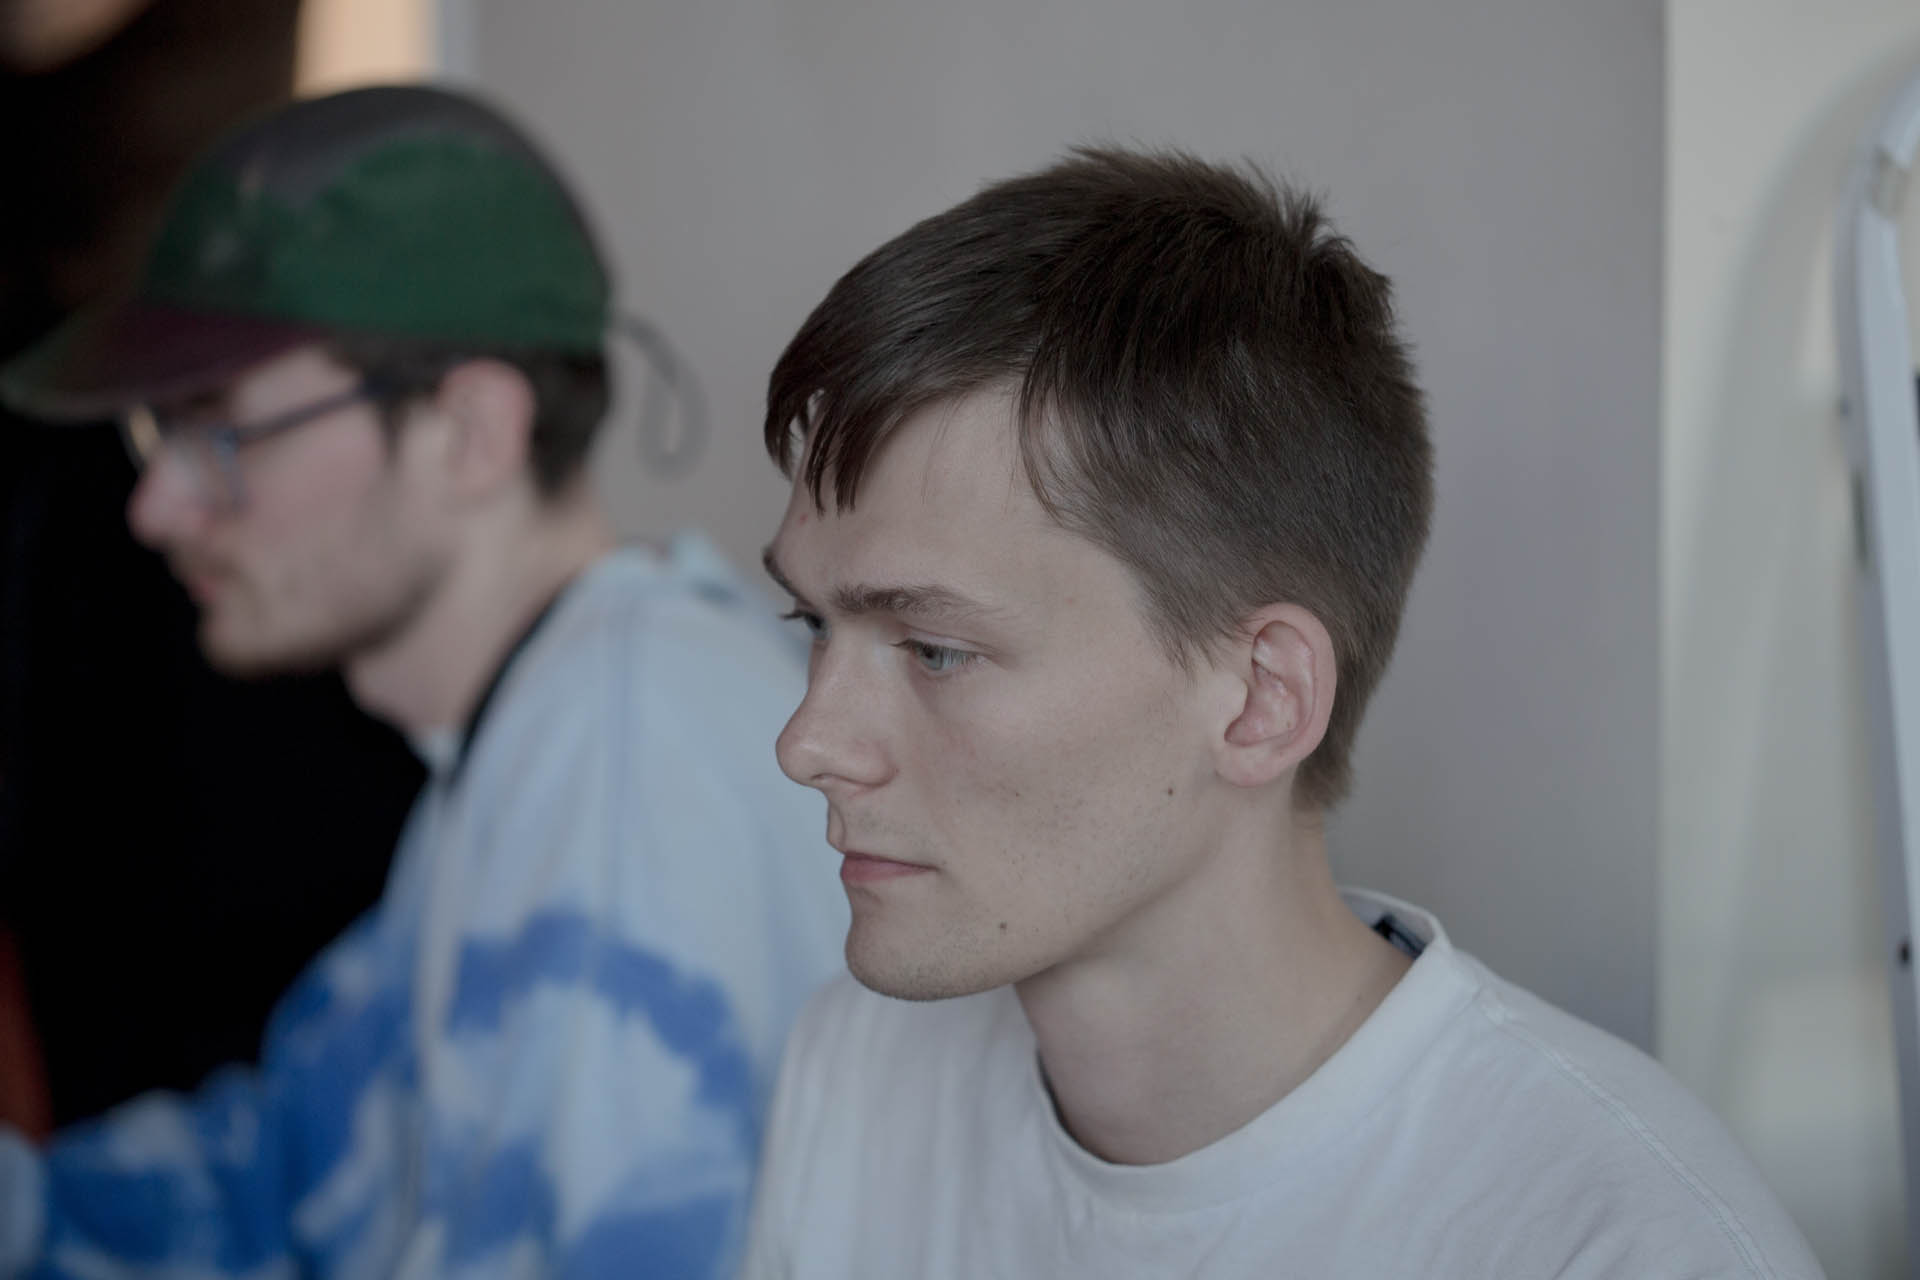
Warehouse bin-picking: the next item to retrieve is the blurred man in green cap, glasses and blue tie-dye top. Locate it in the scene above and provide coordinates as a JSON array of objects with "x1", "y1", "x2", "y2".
[{"x1": 0, "y1": 88, "x2": 845, "y2": 1276}]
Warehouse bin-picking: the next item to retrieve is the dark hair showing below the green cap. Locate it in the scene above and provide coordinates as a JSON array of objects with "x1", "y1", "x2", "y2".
[{"x1": 328, "y1": 334, "x2": 611, "y2": 497}]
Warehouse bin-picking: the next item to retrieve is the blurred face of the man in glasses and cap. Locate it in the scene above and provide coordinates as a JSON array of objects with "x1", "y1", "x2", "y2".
[{"x1": 127, "y1": 345, "x2": 445, "y2": 674}]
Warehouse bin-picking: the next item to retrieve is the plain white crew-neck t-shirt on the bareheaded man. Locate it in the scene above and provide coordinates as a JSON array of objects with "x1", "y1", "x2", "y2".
[{"x1": 745, "y1": 892, "x2": 1820, "y2": 1280}]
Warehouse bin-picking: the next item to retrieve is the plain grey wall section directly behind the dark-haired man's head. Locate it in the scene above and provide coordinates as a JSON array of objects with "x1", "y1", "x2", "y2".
[{"x1": 464, "y1": 0, "x2": 1663, "y2": 1044}]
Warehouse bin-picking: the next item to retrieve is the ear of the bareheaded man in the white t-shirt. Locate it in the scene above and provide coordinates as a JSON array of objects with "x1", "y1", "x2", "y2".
[{"x1": 1213, "y1": 604, "x2": 1336, "y2": 787}]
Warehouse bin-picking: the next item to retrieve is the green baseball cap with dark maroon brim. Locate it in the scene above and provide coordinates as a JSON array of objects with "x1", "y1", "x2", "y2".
[{"x1": 0, "y1": 84, "x2": 611, "y2": 420}]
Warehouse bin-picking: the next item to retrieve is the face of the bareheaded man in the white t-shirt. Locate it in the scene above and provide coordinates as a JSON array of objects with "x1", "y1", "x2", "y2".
[{"x1": 768, "y1": 393, "x2": 1215, "y2": 1000}]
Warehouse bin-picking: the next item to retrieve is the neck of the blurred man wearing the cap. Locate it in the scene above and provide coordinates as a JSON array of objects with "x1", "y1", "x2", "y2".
[{"x1": 344, "y1": 495, "x2": 614, "y2": 737}]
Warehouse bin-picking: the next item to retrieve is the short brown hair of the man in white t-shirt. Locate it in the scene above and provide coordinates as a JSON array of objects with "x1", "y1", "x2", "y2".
[{"x1": 766, "y1": 148, "x2": 1432, "y2": 810}]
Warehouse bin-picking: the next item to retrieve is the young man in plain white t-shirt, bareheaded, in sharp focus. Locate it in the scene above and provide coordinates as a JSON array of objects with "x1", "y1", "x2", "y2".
[{"x1": 747, "y1": 152, "x2": 1818, "y2": 1280}]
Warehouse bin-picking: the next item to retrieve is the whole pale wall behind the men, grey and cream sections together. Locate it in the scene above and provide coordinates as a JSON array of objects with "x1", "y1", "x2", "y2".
[{"x1": 438, "y1": 0, "x2": 1920, "y2": 1280}]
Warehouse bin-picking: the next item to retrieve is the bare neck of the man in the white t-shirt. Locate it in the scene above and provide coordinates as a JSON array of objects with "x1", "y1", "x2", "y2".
[{"x1": 1018, "y1": 809, "x2": 1409, "y2": 1165}]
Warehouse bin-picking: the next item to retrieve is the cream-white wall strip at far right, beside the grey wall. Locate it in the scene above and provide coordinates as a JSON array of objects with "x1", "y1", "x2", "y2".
[{"x1": 1657, "y1": 0, "x2": 1920, "y2": 1280}]
